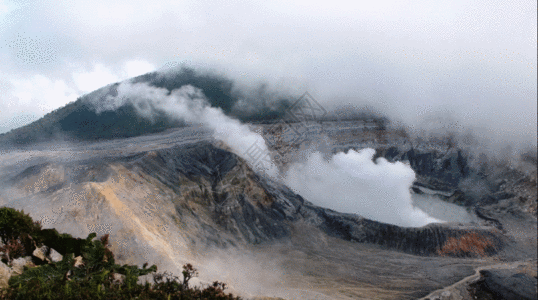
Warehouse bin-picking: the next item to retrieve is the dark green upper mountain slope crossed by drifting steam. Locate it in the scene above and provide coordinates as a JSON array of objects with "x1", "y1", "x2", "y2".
[{"x1": 0, "y1": 68, "x2": 289, "y2": 146}]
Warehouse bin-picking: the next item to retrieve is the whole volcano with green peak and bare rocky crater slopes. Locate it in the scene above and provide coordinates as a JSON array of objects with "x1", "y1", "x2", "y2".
[{"x1": 0, "y1": 70, "x2": 537, "y2": 299}]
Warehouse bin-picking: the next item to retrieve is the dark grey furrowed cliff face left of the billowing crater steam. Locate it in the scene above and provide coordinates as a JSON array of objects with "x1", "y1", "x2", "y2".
[{"x1": 124, "y1": 142, "x2": 303, "y2": 243}]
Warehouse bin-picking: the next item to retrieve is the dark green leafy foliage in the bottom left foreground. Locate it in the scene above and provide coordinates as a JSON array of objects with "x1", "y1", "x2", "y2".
[{"x1": 0, "y1": 207, "x2": 239, "y2": 300}]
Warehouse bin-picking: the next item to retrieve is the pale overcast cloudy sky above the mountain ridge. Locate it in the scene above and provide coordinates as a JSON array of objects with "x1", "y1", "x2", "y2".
[{"x1": 0, "y1": 0, "x2": 537, "y2": 143}]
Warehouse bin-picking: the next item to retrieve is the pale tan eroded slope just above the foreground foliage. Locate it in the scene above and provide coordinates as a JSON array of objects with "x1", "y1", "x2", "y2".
[{"x1": 2, "y1": 163, "x2": 192, "y2": 271}]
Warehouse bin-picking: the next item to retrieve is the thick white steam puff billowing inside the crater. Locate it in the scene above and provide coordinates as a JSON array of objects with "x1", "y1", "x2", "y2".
[{"x1": 285, "y1": 149, "x2": 441, "y2": 227}]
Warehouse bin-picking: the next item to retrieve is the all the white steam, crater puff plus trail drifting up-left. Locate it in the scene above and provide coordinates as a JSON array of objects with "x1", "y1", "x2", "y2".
[{"x1": 104, "y1": 83, "x2": 440, "y2": 226}]
